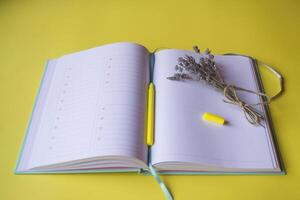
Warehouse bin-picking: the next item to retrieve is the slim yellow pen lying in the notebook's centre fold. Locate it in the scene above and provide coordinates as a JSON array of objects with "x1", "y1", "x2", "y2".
[{"x1": 146, "y1": 83, "x2": 155, "y2": 146}]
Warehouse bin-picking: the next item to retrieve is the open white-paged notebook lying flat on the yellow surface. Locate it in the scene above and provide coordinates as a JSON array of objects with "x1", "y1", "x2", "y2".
[{"x1": 16, "y1": 43, "x2": 283, "y2": 174}]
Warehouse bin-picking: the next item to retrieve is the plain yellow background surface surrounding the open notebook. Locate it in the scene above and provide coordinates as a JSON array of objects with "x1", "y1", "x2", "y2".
[{"x1": 0, "y1": 0, "x2": 300, "y2": 200}]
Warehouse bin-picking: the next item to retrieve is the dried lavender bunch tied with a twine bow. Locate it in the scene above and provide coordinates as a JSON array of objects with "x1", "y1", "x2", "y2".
[{"x1": 167, "y1": 47, "x2": 266, "y2": 125}]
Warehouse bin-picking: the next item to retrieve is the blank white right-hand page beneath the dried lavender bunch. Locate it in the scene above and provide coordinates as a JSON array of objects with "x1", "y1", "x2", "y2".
[{"x1": 152, "y1": 50, "x2": 275, "y2": 169}]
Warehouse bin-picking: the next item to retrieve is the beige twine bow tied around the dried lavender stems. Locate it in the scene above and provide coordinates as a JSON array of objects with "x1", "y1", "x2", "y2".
[{"x1": 223, "y1": 85, "x2": 270, "y2": 125}]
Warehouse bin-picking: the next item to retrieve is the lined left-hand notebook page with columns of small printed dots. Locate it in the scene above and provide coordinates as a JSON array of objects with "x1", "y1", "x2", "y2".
[{"x1": 27, "y1": 43, "x2": 149, "y2": 168}]
